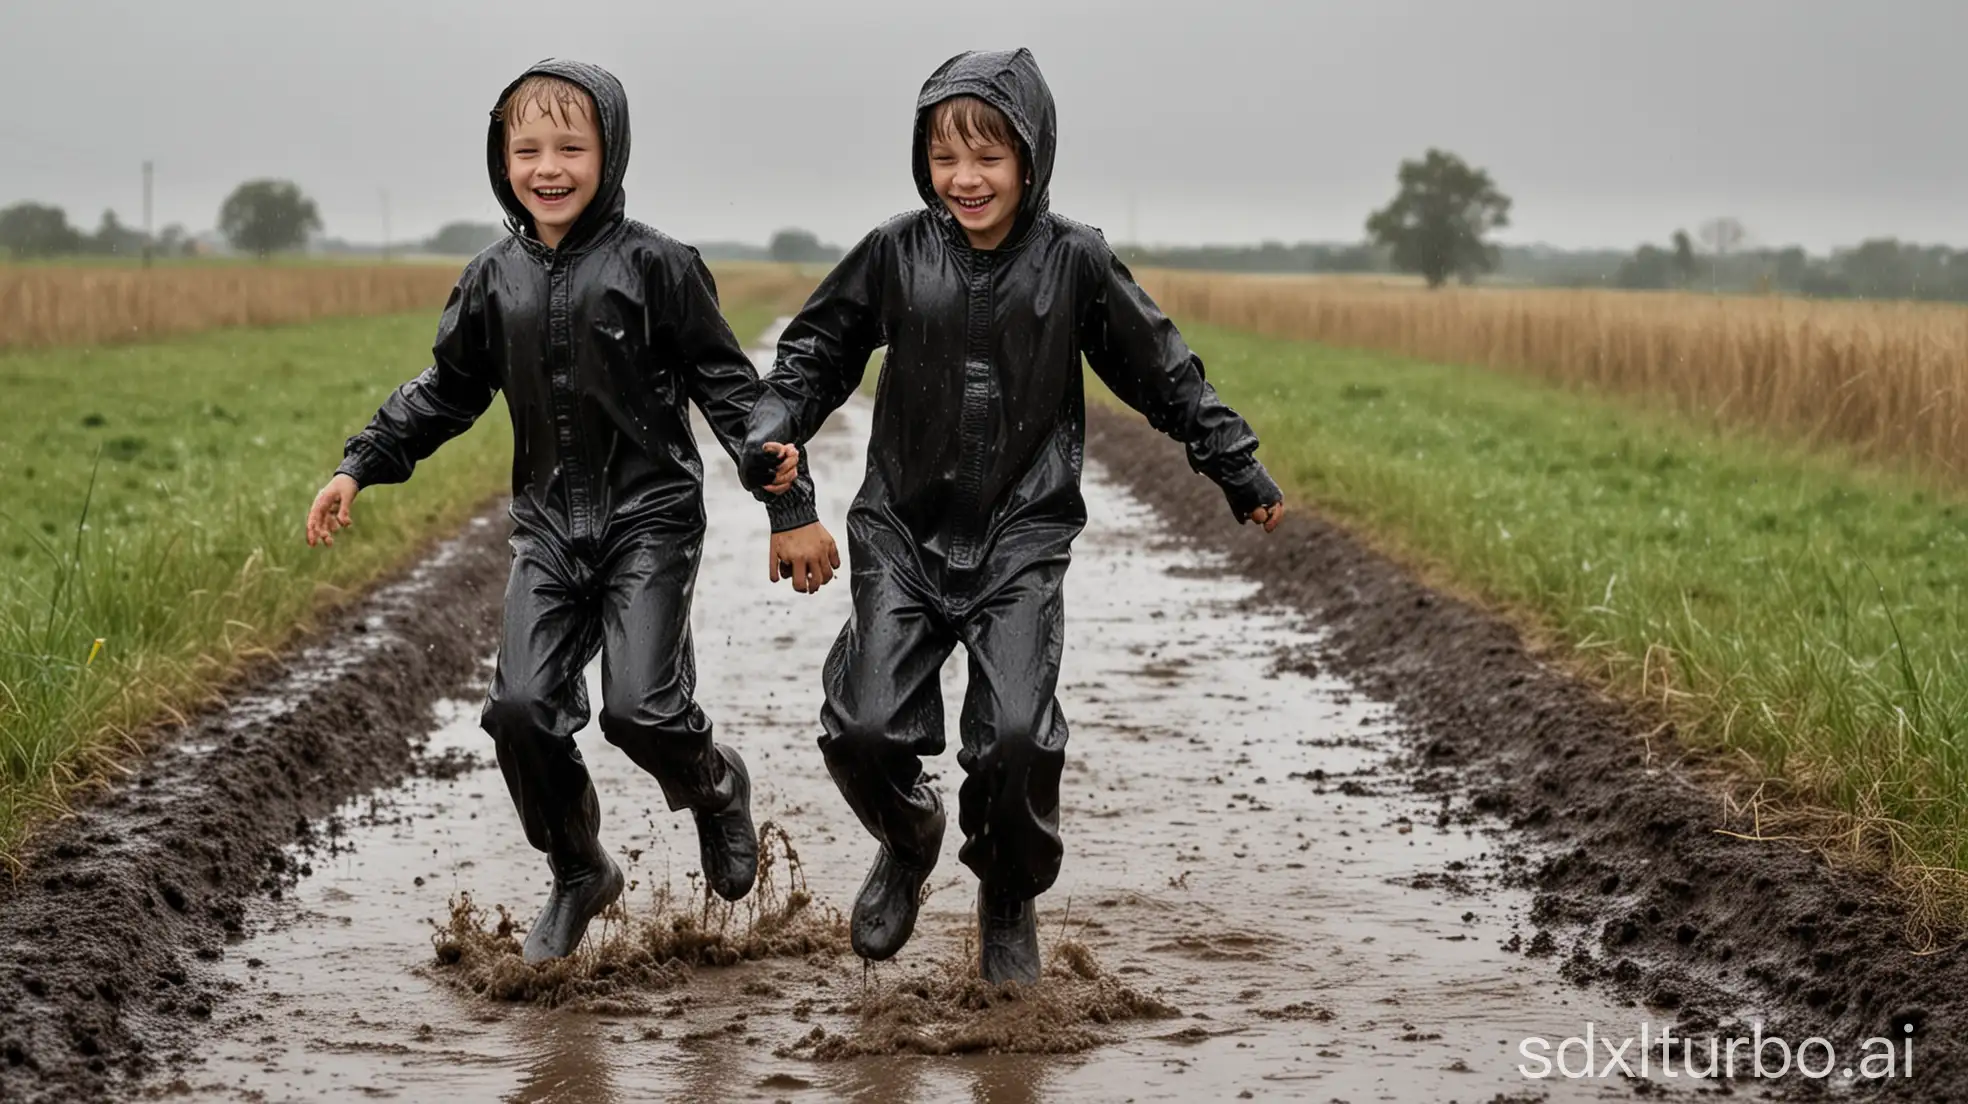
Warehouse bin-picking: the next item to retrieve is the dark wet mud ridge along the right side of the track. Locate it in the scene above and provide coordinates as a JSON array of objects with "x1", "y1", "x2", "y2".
[{"x1": 1088, "y1": 409, "x2": 1968, "y2": 1100}]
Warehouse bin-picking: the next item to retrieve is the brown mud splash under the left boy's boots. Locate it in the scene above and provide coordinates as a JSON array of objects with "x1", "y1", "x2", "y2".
[{"x1": 431, "y1": 821, "x2": 852, "y2": 1015}]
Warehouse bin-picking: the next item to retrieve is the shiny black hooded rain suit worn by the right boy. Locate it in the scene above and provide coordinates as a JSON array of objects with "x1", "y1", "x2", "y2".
[{"x1": 752, "y1": 49, "x2": 1279, "y2": 897}]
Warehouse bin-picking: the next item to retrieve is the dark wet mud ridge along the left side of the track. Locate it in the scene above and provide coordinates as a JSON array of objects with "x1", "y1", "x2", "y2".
[{"x1": 0, "y1": 504, "x2": 508, "y2": 1100}]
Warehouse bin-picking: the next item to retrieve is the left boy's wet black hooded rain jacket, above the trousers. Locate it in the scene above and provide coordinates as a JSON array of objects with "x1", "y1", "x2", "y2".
[{"x1": 340, "y1": 61, "x2": 813, "y2": 551}]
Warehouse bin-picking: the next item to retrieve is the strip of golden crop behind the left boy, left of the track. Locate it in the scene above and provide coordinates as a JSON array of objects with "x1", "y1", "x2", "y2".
[{"x1": 0, "y1": 262, "x2": 819, "y2": 350}]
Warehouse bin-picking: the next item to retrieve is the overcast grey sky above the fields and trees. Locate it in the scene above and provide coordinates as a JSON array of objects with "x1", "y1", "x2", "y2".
[{"x1": 0, "y1": 0, "x2": 1968, "y2": 250}]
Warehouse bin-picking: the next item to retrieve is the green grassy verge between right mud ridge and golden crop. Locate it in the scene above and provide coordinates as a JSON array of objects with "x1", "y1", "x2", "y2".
[{"x1": 1096, "y1": 327, "x2": 1968, "y2": 929}]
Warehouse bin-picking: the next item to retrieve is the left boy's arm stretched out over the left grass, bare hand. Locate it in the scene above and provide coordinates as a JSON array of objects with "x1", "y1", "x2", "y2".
[{"x1": 307, "y1": 262, "x2": 498, "y2": 545}]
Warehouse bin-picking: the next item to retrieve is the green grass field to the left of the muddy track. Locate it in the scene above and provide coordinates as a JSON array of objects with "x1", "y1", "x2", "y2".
[{"x1": 0, "y1": 305, "x2": 771, "y2": 862}]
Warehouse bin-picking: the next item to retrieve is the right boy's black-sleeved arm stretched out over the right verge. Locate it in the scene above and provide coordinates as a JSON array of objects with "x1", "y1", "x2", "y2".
[{"x1": 1080, "y1": 244, "x2": 1285, "y2": 531}]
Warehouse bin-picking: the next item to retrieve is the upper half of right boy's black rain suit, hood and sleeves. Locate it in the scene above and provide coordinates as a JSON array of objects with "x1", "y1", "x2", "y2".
[{"x1": 754, "y1": 49, "x2": 1277, "y2": 592}]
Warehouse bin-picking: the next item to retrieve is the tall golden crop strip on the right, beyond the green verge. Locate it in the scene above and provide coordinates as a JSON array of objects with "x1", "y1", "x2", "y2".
[{"x1": 1138, "y1": 270, "x2": 1968, "y2": 478}]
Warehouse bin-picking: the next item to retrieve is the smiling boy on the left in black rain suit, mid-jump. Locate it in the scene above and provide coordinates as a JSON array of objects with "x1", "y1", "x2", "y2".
[{"x1": 307, "y1": 61, "x2": 838, "y2": 962}]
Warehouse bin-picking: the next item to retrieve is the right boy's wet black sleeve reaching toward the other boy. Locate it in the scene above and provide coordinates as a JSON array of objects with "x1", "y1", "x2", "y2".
[{"x1": 750, "y1": 228, "x2": 888, "y2": 454}]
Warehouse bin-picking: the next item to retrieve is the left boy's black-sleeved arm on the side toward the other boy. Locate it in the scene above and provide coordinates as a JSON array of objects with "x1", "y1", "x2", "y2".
[{"x1": 669, "y1": 250, "x2": 819, "y2": 533}]
